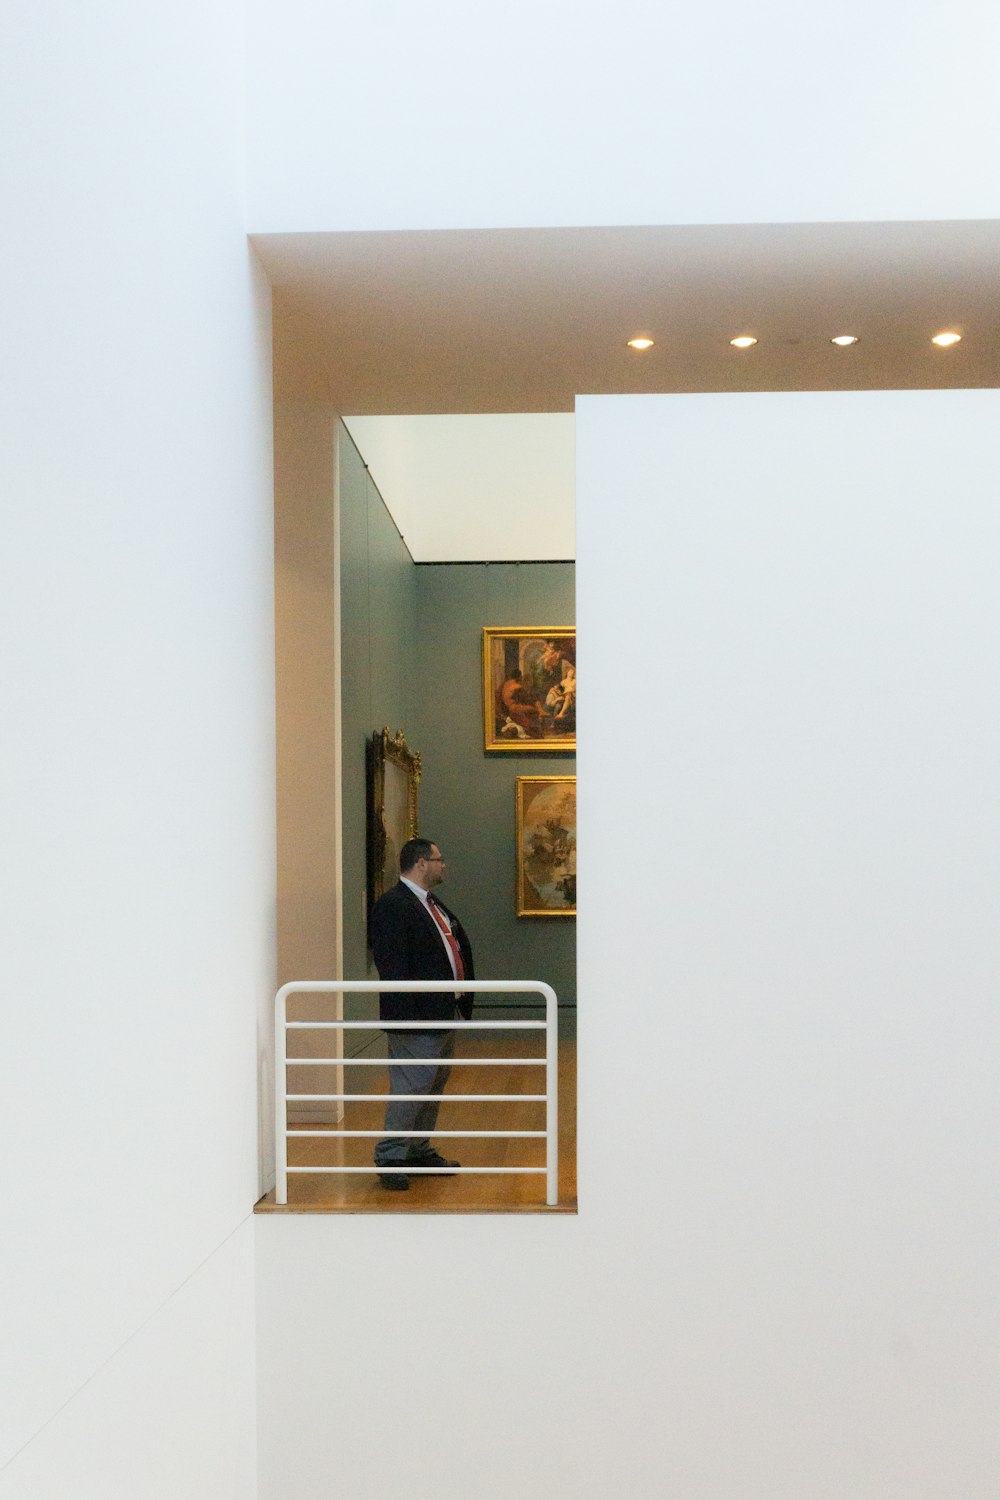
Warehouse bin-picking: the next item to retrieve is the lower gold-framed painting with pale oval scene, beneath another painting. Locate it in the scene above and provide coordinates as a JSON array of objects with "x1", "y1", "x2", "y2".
[{"x1": 514, "y1": 776, "x2": 576, "y2": 917}]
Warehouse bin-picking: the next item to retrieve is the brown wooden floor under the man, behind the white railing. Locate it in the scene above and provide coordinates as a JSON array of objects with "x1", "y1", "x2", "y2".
[{"x1": 256, "y1": 1032, "x2": 576, "y2": 1214}]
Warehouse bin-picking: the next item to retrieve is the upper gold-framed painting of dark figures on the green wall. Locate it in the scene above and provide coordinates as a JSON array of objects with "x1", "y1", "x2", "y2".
[{"x1": 483, "y1": 626, "x2": 576, "y2": 755}]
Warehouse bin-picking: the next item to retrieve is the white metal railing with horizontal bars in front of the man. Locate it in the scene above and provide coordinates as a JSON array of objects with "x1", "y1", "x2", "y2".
[{"x1": 274, "y1": 980, "x2": 559, "y2": 1206}]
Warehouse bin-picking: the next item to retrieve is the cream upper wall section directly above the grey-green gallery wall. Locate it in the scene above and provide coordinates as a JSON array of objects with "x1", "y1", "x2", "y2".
[{"x1": 343, "y1": 411, "x2": 576, "y2": 563}]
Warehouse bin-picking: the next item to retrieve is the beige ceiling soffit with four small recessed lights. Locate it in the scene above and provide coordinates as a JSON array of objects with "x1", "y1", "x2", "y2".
[{"x1": 253, "y1": 221, "x2": 1000, "y2": 414}]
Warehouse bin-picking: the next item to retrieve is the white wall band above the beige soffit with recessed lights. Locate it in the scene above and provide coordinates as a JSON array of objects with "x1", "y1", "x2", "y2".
[{"x1": 250, "y1": 0, "x2": 1000, "y2": 233}]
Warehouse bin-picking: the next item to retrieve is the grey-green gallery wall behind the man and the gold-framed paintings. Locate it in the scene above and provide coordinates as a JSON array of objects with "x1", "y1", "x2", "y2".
[{"x1": 340, "y1": 428, "x2": 576, "y2": 1050}]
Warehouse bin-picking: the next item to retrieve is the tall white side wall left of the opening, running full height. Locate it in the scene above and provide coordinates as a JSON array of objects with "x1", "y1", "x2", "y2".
[{"x1": 0, "y1": 0, "x2": 274, "y2": 1500}]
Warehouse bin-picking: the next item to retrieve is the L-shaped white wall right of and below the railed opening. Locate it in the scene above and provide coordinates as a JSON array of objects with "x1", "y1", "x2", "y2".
[{"x1": 256, "y1": 392, "x2": 1000, "y2": 1500}]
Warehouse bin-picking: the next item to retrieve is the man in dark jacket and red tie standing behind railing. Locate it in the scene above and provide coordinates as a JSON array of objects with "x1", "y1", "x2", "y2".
[{"x1": 372, "y1": 839, "x2": 475, "y2": 1193}]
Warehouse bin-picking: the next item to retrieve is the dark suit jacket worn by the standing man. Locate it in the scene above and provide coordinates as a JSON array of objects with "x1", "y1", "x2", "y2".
[{"x1": 372, "y1": 881, "x2": 475, "y2": 1022}]
